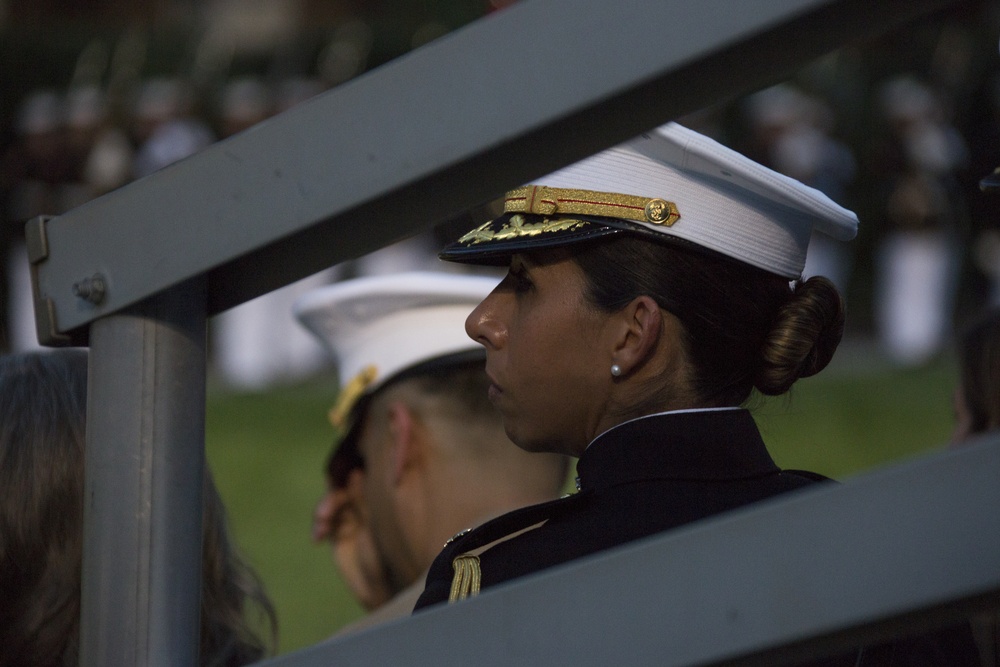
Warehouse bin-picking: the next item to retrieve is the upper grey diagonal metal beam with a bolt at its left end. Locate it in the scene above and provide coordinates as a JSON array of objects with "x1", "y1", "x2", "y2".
[{"x1": 28, "y1": 0, "x2": 949, "y2": 344}]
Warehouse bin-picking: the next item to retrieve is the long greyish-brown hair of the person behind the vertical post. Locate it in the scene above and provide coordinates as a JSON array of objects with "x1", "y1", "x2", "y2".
[{"x1": 0, "y1": 349, "x2": 277, "y2": 667}]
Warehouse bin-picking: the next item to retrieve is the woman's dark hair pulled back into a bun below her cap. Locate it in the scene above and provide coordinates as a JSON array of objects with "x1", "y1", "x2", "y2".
[{"x1": 573, "y1": 235, "x2": 844, "y2": 407}]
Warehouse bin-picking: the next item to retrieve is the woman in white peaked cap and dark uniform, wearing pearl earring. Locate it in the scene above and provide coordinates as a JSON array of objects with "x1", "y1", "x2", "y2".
[{"x1": 417, "y1": 123, "x2": 975, "y2": 665}]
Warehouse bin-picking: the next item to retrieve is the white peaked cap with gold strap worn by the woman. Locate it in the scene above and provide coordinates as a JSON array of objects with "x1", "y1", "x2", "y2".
[{"x1": 441, "y1": 123, "x2": 858, "y2": 279}]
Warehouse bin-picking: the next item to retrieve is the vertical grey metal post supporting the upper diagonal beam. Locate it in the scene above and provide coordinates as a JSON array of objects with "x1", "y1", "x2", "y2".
[{"x1": 80, "y1": 278, "x2": 206, "y2": 667}]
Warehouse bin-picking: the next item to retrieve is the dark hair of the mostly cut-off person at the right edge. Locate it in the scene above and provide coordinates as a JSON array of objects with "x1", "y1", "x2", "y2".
[{"x1": 958, "y1": 308, "x2": 1000, "y2": 433}]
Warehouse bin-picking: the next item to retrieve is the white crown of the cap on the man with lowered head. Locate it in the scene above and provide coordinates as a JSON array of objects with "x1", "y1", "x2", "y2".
[{"x1": 293, "y1": 272, "x2": 499, "y2": 422}]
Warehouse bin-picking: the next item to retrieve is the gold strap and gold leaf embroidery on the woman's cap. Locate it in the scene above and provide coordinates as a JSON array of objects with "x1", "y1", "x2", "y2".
[{"x1": 458, "y1": 185, "x2": 681, "y2": 245}]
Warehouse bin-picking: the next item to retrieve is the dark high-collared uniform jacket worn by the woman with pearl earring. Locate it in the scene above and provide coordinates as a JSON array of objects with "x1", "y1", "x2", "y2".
[{"x1": 416, "y1": 409, "x2": 978, "y2": 667}]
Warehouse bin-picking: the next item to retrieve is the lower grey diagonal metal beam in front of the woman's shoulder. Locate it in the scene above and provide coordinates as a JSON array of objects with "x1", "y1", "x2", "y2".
[{"x1": 263, "y1": 436, "x2": 1000, "y2": 667}]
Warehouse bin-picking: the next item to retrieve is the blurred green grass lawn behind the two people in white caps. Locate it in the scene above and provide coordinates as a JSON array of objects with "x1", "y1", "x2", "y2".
[{"x1": 207, "y1": 346, "x2": 955, "y2": 653}]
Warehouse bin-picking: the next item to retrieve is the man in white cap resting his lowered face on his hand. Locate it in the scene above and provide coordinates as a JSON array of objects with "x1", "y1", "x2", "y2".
[{"x1": 295, "y1": 273, "x2": 567, "y2": 629}]
